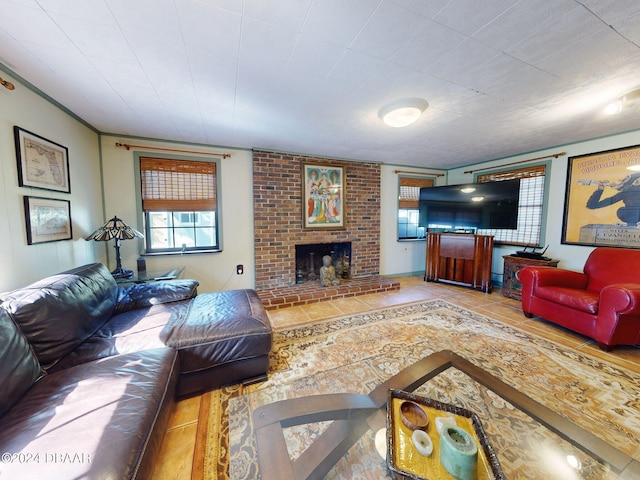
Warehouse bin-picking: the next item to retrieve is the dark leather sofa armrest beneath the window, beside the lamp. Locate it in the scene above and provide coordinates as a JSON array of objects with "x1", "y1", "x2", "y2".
[{"x1": 114, "y1": 280, "x2": 199, "y2": 315}]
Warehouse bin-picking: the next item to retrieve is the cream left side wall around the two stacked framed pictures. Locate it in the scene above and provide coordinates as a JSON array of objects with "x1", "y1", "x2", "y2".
[{"x1": 0, "y1": 69, "x2": 104, "y2": 292}]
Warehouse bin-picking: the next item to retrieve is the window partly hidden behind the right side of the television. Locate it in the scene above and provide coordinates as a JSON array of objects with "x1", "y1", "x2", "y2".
[{"x1": 477, "y1": 165, "x2": 546, "y2": 246}]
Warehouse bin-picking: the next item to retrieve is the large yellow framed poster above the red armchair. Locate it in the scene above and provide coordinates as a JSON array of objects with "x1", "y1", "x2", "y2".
[{"x1": 562, "y1": 145, "x2": 640, "y2": 248}]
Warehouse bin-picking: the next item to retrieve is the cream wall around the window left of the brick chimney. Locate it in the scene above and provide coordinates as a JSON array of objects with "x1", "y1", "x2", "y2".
[{"x1": 101, "y1": 135, "x2": 255, "y2": 293}]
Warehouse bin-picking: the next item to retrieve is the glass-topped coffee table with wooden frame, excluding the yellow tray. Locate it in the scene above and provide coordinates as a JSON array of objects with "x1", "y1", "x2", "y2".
[{"x1": 253, "y1": 350, "x2": 640, "y2": 480}]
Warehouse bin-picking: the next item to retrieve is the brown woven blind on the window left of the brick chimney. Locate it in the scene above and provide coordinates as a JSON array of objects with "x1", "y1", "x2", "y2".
[{"x1": 140, "y1": 157, "x2": 217, "y2": 212}]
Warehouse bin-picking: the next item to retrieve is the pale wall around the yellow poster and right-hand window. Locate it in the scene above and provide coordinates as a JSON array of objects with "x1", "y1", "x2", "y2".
[{"x1": 448, "y1": 130, "x2": 640, "y2": 281}]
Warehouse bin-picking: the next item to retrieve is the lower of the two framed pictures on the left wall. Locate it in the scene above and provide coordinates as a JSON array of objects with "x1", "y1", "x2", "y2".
[{"x1": 24, "y1": 196, "x2": 73, "y2": 245}]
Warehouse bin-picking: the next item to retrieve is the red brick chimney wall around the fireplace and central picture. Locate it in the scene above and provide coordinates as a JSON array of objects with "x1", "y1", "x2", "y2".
[{"x1": 253, "y1": 150, "x2": 380, "y2": 290}]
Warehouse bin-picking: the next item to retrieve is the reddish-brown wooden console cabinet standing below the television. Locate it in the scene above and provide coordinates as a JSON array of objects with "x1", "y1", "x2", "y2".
[{"x1": 424, "y1": 233, "x2": 493, "y2": 293}]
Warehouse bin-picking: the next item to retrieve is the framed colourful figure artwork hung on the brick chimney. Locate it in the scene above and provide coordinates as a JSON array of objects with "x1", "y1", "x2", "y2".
[{"x1": 302, "y1": 164, "x2": 346, "y2": 230}]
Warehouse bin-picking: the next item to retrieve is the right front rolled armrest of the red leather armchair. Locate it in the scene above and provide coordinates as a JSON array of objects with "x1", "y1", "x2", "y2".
[{"x1": 594, "y1": 283, "x2": 640, "y2": 345}]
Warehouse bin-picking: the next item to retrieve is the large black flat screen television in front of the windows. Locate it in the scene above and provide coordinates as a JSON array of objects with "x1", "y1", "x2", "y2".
[{"x1": 419, "y1": 179, "x2": 520, "y2": 231}]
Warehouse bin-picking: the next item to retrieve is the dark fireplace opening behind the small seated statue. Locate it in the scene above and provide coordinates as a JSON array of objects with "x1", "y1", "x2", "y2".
[{"x1": 296, "y1": 242, "x2": 351, "y2": 283}]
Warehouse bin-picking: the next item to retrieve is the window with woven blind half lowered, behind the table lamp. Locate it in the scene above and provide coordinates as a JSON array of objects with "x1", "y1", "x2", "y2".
[{"x1": 140, "y1": 157, "x2": 220, "y2": 253}]
